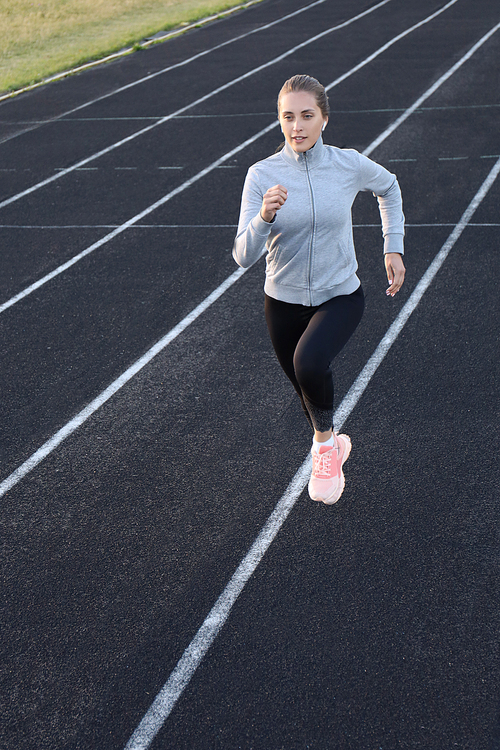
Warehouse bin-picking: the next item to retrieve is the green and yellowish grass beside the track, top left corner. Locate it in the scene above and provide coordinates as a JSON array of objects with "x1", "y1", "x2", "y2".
[{"x1": 0, "y1": 0, "x2": 258, "y2": 92}]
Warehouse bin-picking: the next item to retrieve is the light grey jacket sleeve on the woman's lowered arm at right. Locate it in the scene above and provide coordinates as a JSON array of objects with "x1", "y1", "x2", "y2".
[{"x1": 359, "y1": 154, "x2": 405, "y2": 255}]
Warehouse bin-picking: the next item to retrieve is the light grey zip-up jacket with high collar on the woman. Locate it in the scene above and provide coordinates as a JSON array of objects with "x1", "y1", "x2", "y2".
[{"x1": 233, "y1": 137, "x2": 404, "y2": 306}]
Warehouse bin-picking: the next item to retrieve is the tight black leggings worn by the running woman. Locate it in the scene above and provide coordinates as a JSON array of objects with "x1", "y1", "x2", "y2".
[{"x1": 265, "y1": 287, "x2": 365, "y2": 432}]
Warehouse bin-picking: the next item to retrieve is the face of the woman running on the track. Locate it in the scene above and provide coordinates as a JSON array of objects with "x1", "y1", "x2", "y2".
[{"x1": 279, "y1": 91, "x2": 328, "y2": 153}]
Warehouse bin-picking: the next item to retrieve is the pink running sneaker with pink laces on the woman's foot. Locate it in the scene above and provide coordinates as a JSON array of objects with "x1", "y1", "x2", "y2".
[{"x1": 309, "y1": 435, "x2": 351, "y2": 505}]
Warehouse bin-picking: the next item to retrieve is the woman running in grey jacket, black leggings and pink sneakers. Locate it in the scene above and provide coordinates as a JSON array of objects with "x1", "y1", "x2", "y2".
[{"x1": 233, "y1": 75, "x2": 405, "y2": 504}]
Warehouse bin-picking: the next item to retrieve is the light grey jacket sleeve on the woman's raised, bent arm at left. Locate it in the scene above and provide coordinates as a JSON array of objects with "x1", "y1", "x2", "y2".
[{"x1": 233, "y1": 167, "x2": 273, "y2": 268}]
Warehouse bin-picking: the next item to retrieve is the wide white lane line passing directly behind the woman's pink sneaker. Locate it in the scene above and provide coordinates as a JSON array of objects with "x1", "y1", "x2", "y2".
[{"x1": 125, "y1": 154, "x2": 500, "y2": 750}]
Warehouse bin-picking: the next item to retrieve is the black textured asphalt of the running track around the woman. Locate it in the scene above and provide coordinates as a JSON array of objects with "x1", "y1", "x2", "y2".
[{"x1": 0, "y1": 0, "x2": 500, "y2": 750}]
